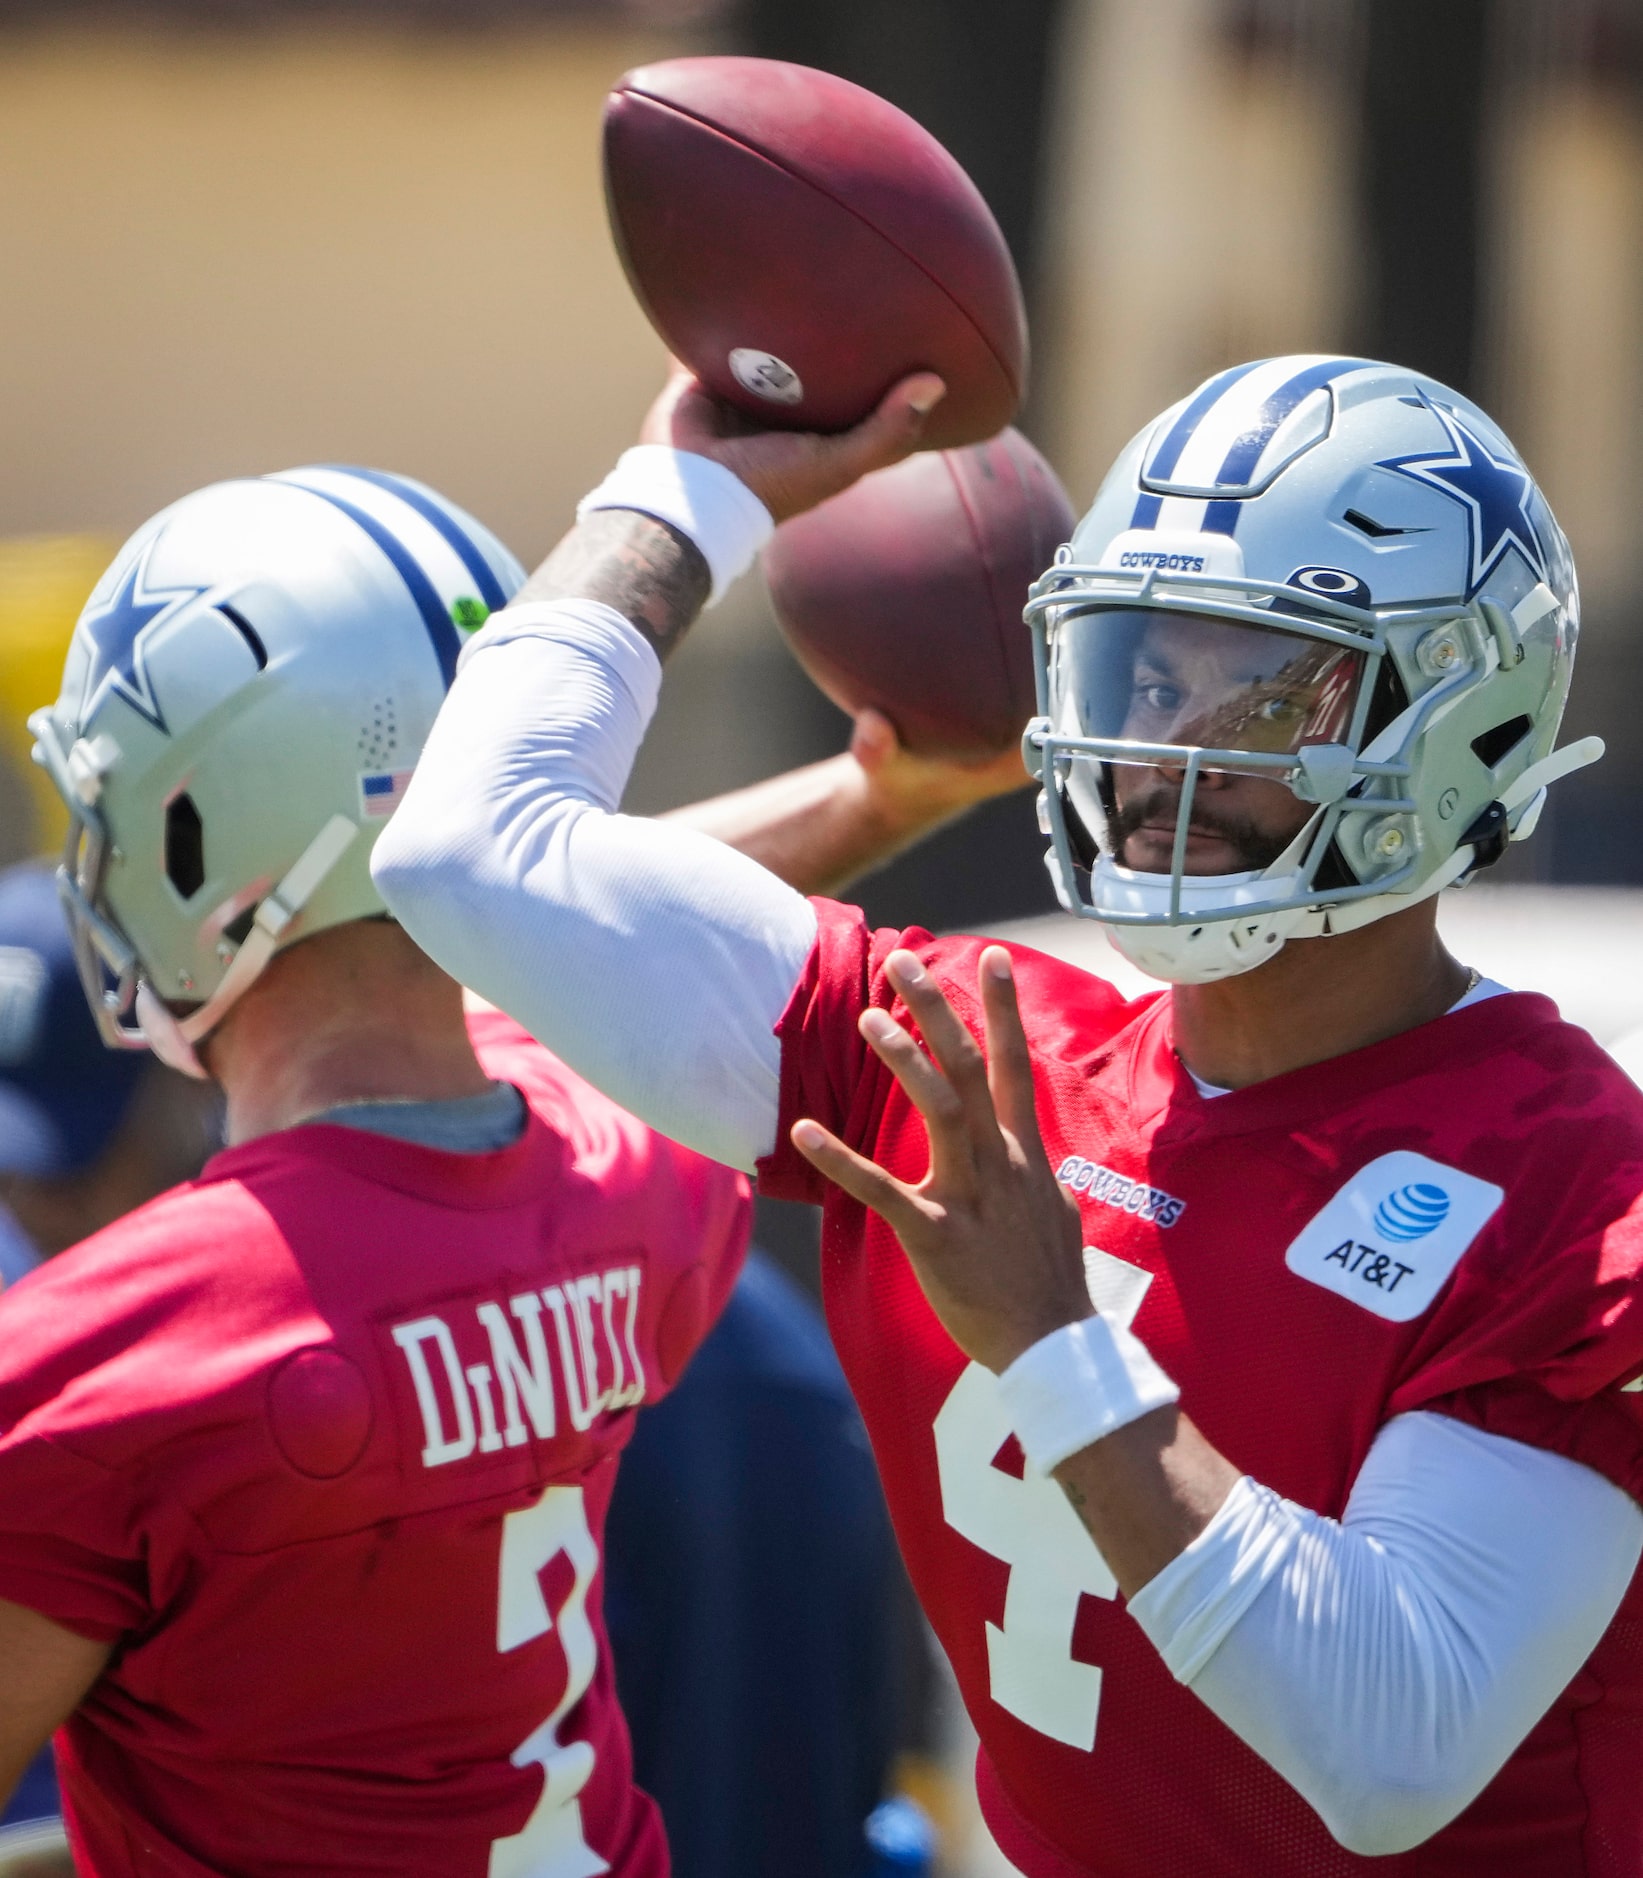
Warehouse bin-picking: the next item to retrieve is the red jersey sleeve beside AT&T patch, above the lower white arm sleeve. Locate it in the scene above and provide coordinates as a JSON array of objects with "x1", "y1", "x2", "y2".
[{"x1": 1390, "y1": 1096, "x2": 1643, "y2": 1501}]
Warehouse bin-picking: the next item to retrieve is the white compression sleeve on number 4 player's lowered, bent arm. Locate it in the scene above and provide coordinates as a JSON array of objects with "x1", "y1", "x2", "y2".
[{"x1": 1129, "y1": 1412, "x2": 1643, "y2": 1855}]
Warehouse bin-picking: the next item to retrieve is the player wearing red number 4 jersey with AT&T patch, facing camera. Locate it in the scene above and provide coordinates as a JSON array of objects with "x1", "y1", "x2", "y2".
[{"x1": 377, "y1": 357, "x2": 1643, "y2": 1878}]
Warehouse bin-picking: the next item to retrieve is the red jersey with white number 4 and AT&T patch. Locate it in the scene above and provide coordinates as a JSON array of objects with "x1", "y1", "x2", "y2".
[{"x1": 760, "y1": 901, "x2": 1643, "y2": 1878}]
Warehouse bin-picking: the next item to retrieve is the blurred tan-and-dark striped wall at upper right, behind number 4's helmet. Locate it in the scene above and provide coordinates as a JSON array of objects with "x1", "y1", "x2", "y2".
[{"x1": 1036, "y1": 0, "x2": 1643, "y2": 883}]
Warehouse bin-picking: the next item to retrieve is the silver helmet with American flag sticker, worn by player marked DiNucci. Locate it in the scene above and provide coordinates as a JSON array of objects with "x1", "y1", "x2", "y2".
[{"x1": 30, "y1": 466, "x2": 524, "y2": 1074}]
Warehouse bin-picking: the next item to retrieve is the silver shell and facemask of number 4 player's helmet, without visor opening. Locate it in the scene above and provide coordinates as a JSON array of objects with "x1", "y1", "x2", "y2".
[{"x1": 1029, "y1": 355, "x2": 1592, "y2": 982}]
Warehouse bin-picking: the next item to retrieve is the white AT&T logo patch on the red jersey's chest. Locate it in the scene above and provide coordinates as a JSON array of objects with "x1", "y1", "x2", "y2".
[{"x1": 1284, "y1": 1149, "x2": 1506, "y2": 1324}]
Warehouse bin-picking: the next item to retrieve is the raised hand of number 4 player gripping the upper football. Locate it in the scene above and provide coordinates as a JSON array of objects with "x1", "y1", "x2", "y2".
[{"x1": 638, "y1": 364, "x2": 946, "y2": 522}]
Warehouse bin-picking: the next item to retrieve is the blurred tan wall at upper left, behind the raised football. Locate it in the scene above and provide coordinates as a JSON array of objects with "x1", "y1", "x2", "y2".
[{"x1": 0, "y1": 24, "x2": 687, "y2": 558}]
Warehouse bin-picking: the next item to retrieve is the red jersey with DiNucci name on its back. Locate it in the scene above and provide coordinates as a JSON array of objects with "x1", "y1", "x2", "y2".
[{"x1": 0, "y1": 1016, "x2": 747, "y2": 1878}]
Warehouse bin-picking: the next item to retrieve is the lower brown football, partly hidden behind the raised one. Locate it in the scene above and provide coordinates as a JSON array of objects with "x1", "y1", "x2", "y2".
[{"x1": 764, "y1": 430, "x2": 1076, "y2": 755}]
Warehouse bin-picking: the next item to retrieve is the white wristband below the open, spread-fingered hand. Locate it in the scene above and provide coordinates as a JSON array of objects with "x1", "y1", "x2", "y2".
[{"x1": 999, "y1": 1316, "x2": 1181, "y2": 1474}]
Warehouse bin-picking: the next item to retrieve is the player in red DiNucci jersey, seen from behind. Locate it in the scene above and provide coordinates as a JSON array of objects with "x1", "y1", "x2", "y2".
[{"x1": 0, "y1": 466, "x2": 1020, "y2": 1878}]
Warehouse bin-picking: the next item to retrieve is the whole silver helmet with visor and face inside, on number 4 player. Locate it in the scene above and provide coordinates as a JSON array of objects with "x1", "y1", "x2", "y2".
[{"x1": 1025, "y1": 357, "x2": 1602, "y2": 984}]
